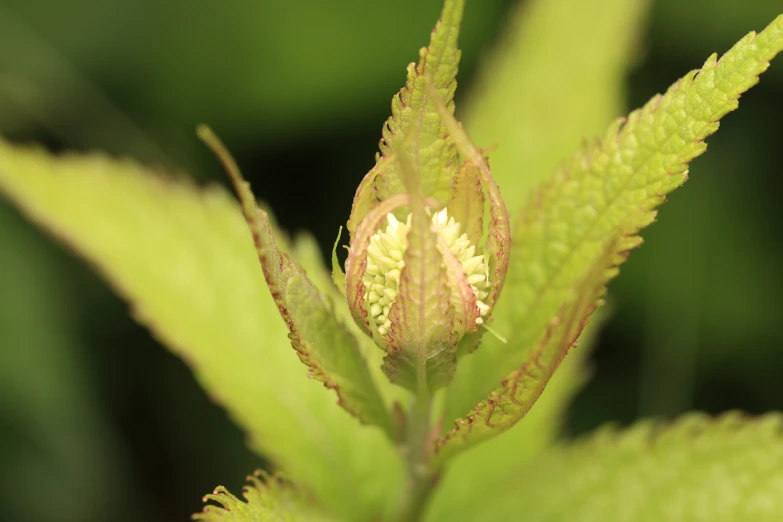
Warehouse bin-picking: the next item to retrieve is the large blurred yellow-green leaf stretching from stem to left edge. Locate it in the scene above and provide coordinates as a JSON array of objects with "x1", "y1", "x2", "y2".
[{"x1": 0, "y1": 137, "x2": 402, "y2": 520}]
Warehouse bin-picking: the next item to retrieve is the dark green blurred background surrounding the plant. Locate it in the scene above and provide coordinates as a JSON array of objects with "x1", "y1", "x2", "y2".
[{"x1": 0, "y1": 0, "x2": 783, "y2": 522}]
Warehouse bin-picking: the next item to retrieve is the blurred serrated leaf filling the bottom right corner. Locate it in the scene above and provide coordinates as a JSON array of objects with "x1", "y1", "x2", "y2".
[{"x1": 461, "y1": 413, "x2": 783, "y2": 522}]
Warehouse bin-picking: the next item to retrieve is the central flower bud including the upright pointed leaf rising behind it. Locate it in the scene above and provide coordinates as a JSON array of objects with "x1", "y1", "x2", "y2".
[{"x1": 335, "y1": 68, "x2": 511, "y2": 386}]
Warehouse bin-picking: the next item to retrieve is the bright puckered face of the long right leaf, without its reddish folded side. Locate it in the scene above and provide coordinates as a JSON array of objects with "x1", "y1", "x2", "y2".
[{"x1": 446, "y1": 16, "x2": 783, "y2": 450}]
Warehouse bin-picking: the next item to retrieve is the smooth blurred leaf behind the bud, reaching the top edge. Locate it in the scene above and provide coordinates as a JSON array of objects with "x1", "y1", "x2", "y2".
[{"x1": 461, "y1": 0, "x2": 649, "y2": 216}]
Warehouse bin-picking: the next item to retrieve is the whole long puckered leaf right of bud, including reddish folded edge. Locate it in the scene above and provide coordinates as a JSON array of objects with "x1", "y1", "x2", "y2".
[{"x1": 439, "y1": 8, "x2": 783, "y2": 458}]
